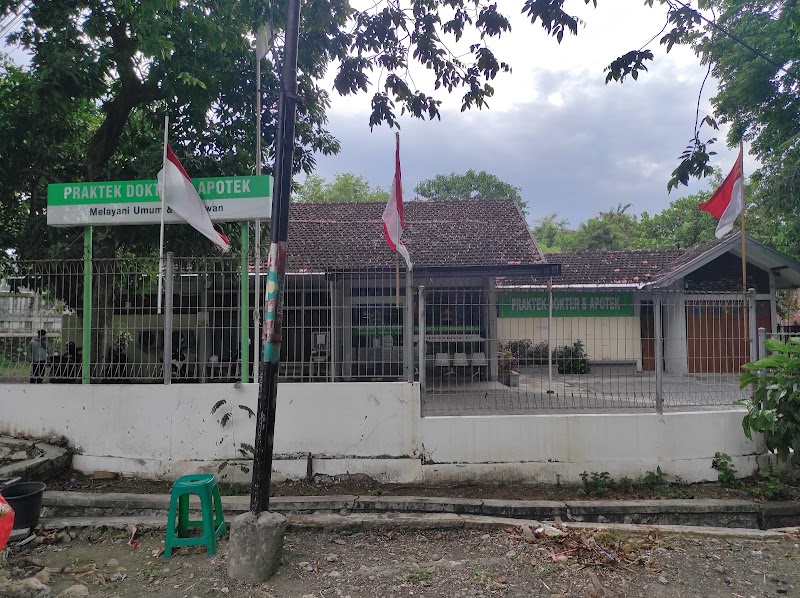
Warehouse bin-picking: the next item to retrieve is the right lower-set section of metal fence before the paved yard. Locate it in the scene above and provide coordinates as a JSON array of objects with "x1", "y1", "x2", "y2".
[{"x1": 424, "y1": 289, "x2": 760, "y2": 415}]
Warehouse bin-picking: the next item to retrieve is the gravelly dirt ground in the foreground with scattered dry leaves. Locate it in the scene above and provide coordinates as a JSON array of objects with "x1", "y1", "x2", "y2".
[{"x1": 0, "y1": 527, "x2": 800, "y2": 598}]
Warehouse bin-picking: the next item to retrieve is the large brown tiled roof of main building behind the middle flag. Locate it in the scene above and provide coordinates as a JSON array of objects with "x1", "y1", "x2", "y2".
[{"x1": 288, "y1": 200, "x2": 544, "y2": 272}]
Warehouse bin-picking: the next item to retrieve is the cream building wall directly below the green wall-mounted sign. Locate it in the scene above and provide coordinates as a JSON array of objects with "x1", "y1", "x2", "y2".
[{"x1": 497, "y1": 316, "x2": 642, "y2": 369}]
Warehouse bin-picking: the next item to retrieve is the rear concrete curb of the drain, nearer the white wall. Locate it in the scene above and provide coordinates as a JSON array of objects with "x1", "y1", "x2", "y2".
[{"x1": 42, "y1": 491, "x2": 800, "y2": 529}]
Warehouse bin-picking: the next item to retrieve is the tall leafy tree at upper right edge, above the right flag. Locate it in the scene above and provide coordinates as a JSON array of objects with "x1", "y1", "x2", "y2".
[{"x1": 680, "y1": 0, "x2": 800, "y2": 256}]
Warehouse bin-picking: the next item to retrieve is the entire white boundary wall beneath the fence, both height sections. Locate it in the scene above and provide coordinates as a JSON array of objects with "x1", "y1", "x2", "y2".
[{"x1": 0, "y1": 383, "x2": 764, "y2": 483}]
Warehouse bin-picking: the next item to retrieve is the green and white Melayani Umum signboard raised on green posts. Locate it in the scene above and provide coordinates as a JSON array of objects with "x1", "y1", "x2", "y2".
[{"x1": 47, "y1": 176, "x2": 272, "y2": 226}]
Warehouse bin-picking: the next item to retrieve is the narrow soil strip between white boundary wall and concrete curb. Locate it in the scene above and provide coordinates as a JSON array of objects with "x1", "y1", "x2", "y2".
[{"x1": 47, "y1": 471, "x2": 800, "y2": 501}]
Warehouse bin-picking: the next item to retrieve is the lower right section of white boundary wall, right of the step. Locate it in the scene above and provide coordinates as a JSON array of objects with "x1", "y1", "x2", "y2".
[{"x1": 420, "y1": 409, "x2": 764, "y2": 483}]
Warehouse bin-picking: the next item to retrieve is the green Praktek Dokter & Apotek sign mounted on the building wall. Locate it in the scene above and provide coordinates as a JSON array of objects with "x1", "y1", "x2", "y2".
[{"x1": 497, "y1": 291, "x2": 633, "y2": 318}]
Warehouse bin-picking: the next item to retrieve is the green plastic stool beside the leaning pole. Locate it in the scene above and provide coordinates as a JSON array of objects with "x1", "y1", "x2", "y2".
[{"x1": 164, "y1": 473, "x2": 225, "y2": 559}]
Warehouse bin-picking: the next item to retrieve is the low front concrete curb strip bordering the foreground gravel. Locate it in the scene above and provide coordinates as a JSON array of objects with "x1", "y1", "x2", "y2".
[{"x1": 41, "y1": 512, "x2": 800, "y2": 540}]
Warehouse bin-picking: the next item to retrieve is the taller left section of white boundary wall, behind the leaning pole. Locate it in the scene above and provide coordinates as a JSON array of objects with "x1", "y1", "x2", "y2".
[{"x1": 0, "y1": 383, "x2": 420, "y2": 488}]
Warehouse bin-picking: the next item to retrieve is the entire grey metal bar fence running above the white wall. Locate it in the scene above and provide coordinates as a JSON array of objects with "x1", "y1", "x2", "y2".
[{"x1": 0, "y1": 256, "x2": 776, "y2": 416}]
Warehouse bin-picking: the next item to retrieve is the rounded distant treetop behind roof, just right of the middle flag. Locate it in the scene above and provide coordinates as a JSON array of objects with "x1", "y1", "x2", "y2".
[{"x1": 414, "y1": 170, "x2": 527, "y2": 213}]
